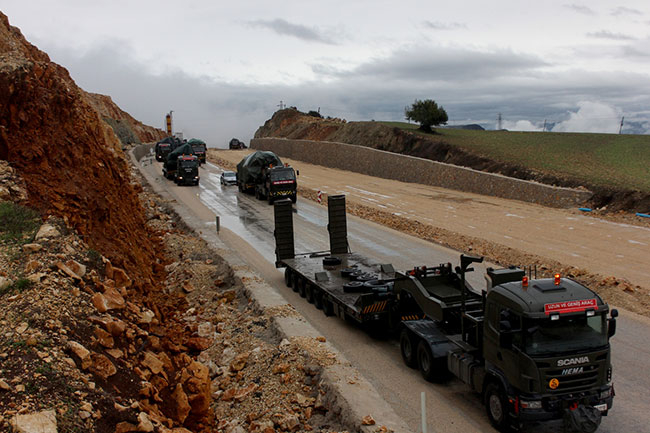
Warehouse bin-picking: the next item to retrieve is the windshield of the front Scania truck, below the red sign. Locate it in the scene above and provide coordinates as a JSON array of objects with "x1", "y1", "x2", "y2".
[{"x1": 524, "y1": 314, "x2": 607, "y2": 355}]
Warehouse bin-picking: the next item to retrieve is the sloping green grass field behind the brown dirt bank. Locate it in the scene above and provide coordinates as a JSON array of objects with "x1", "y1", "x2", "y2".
[{"x1": 382, "y1": 122, "x2": 650, "y2": 192}]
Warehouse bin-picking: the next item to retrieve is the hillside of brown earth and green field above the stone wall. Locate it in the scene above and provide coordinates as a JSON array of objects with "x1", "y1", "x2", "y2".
[{"x1": 255, "y1": 109, "x2": 650, "y2": 213}]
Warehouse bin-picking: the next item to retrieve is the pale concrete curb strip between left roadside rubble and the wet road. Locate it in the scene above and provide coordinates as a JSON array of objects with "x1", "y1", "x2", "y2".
[{"x1": 129, "y1": 144, "x2": 412, "y2": 433}]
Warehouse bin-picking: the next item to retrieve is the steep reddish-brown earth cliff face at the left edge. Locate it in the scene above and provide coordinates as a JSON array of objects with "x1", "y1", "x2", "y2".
[{"x1": 0, "y1": 11, "x2": 156, "y2": 281}]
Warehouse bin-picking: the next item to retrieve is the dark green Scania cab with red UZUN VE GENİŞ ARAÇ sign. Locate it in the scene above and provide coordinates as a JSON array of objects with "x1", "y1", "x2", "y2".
[{"x1": 482, "y1": 270, "x2": 618, "y2": 431}]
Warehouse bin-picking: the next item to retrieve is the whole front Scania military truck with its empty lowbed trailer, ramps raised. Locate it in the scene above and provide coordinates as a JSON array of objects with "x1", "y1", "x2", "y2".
[{"x1": 274, "y1": 196, "x2": 618, "y2": 432}]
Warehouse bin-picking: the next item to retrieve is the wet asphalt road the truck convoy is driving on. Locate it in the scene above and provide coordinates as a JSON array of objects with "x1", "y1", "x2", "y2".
[{"x1": 143, "y1": 157, "x2": 650, "y2": 432}]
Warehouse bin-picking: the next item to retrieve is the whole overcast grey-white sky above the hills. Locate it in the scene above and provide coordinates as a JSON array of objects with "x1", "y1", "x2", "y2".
[{"x1": 0, "y1": 0, "x2": 650, "y2": 147}]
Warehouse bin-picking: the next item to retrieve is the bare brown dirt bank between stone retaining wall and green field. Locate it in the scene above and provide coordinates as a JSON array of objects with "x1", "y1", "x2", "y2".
[{"x1": 255, "y1": 108, "x2": 650, "y2": 213}]
